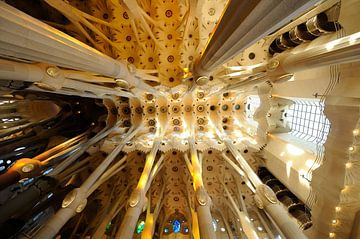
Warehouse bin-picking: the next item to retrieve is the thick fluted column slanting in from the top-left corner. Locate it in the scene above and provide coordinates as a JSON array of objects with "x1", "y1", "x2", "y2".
[{"x1": 0, "y1": 1, "x2": 157, "y2": 94}]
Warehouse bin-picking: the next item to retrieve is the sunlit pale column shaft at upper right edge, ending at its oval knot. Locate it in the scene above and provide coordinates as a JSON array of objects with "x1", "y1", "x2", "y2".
[{"x1": 267, "y1": 32, "x2": 360, "y2": 76}]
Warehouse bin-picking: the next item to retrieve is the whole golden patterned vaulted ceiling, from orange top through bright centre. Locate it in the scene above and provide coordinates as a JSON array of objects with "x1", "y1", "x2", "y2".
[{"x1": 40, "y1": 0, "x2": 265, "y2": 228}]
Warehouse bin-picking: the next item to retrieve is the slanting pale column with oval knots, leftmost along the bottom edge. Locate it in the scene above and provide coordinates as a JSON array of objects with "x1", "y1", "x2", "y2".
[{"x1": 35, "y1": 127, "x2": 140, "y2": 239}]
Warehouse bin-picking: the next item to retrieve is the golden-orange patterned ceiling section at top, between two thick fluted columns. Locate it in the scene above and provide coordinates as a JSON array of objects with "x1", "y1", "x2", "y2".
[{"x1": 62, "y1": 0, "x2": 226, "y2": 87}]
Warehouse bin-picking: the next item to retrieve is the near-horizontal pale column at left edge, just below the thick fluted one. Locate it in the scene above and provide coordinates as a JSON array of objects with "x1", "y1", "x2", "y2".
[{"x1": 0, "y1": 59, "x2": 133, "y2": 98}]
